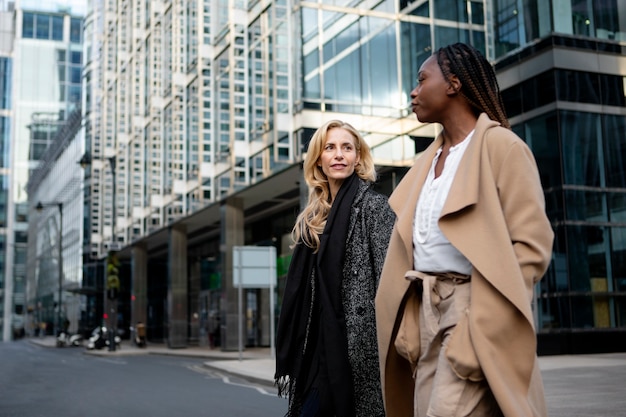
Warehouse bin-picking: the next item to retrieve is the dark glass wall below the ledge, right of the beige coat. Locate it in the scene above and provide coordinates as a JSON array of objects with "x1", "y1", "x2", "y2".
[{"x1": 515, "y1": 110, "x2": 626, "y2": 331}]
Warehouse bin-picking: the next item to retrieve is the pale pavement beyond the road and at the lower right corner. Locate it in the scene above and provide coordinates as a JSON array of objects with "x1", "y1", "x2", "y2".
[{"x1": 29, "y1": 337, "x2": 626, "y2": 417}]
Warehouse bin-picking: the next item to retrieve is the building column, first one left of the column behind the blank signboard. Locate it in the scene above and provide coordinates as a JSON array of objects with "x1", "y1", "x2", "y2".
[{"x1": 167, "y1": 225, "x2": 188, "y2": 349}]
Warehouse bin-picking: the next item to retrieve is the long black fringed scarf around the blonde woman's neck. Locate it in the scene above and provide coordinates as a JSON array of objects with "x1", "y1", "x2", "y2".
[{"x1": 275, "y1": 174, "x2": 359, "y2": 417}]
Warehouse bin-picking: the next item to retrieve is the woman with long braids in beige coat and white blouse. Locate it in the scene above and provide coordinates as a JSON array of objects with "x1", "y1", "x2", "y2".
[{"x1": 376, "y1": 43, "x2": 554, "y2": 417}]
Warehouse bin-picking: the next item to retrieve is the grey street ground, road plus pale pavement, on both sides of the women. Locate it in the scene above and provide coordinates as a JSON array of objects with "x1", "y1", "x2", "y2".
[{"x1": 0, "y1": 338, "x2": 626, "y2": 417}]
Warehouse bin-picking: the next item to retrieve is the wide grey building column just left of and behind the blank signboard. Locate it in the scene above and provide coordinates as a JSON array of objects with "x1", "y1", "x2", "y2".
[{"x1": 220, "y1": 198, "x2": 245, "y2": 351}]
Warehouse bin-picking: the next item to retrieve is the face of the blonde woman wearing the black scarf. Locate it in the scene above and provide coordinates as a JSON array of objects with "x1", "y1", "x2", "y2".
[{"x1": 317, "y1": 127, "x2": 360, "y2": 189}]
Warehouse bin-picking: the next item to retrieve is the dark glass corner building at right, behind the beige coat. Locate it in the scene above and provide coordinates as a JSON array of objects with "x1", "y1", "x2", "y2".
[{"x1": 494, "y1": 0, "x2": 626, "y2": 353}]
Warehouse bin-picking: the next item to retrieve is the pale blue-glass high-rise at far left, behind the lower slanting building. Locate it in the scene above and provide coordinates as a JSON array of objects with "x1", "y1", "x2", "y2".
[{"x1": 0, "y1": 0, "x2": 84, "y2": 340}]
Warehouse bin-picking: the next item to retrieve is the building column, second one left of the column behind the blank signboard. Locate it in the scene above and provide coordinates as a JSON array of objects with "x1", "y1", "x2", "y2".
[{"x1": 130, "y1": 240, "x2": 148, "y2": 328}]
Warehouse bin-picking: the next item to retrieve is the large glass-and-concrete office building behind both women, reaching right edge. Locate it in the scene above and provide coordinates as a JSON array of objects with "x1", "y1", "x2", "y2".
[{"x1": 22, "y1": 0, "x2": 626, "y2": 353}]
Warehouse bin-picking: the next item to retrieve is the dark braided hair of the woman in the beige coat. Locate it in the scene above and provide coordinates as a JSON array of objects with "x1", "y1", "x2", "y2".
[{"x1": 436, "y1": 43, "x2": 511, "y2": 128}]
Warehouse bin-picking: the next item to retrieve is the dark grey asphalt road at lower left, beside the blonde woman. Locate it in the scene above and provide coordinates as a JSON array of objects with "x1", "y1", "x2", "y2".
[{"x1": 0, "y1": 341, "x2": 287, "y2": 417}]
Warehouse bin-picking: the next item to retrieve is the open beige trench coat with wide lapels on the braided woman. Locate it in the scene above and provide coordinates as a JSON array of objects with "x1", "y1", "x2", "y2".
[{"x1": 376, "y1": 114, "x2": 554, "y2": 417}]
